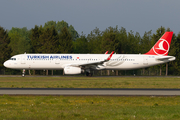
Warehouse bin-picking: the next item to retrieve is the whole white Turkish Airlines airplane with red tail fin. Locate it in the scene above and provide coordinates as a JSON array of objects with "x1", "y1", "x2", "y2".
[{"x1": 4, "y1": 32, "x2": 176, "y2": 76}]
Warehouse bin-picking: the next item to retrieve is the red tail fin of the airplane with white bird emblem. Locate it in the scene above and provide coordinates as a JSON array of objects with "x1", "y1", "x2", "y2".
[{"x1": 145, "y1": 32, "x2": 173, "y2": 55}]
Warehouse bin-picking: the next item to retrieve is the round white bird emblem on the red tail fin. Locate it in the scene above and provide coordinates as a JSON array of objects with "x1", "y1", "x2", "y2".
[{"x1": 153, "y1": 39, "x2": 169, "y2": 55}]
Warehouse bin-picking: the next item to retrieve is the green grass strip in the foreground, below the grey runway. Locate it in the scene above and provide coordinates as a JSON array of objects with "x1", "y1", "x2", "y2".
[{"x1": 0, "y1": 95, "x2": 180, "y2": 120}]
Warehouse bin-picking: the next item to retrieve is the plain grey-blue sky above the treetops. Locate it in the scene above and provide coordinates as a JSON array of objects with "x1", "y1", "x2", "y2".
[{"x1": 0, "y1": 0, "x2": 180, "y2": 36}]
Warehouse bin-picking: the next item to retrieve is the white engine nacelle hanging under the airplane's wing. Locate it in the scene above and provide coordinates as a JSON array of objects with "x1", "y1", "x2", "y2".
[{"x1": 64, "y1": 67, "x2": 81, "y2": 75}]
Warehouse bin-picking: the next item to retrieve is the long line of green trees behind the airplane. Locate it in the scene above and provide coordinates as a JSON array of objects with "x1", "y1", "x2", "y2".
[{"x1": 0, "y1": 21, "x2": 180, "y2": 75}]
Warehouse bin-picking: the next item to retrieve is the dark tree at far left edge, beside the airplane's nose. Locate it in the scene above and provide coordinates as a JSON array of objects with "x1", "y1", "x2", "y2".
[{"x1": 0, "y1": 27, "x2": 11, "y2": 68}]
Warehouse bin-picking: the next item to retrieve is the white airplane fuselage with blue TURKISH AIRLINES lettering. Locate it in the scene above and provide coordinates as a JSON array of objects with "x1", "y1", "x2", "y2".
[{"x1": 4, "y1": 54, "x2": 175, "y2": 70}]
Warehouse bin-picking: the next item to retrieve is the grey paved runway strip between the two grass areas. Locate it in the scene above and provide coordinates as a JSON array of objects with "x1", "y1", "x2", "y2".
[{"x1": 0, "y1": 88, "x2": 180, "y2": 96}]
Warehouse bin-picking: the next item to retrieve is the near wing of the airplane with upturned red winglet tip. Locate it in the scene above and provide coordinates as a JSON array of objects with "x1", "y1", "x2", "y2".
[{"x1": 68, "y1": 51, "x2": 114, "y2": 67}]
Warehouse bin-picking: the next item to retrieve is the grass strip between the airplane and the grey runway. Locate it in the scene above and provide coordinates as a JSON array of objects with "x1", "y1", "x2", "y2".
[{"x1": 0, "y1": 77, "x2": 180, "y2": 88}]
